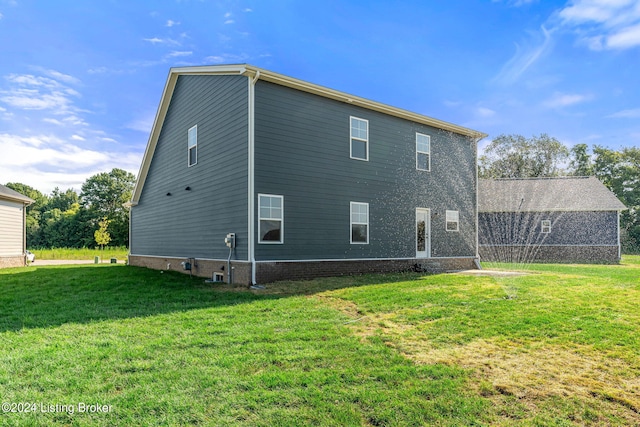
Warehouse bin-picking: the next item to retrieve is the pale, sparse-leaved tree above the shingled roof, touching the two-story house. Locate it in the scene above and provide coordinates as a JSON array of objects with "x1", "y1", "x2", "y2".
[{"x1": 478, "y1": 134, "x2": 569, "y2": 178}]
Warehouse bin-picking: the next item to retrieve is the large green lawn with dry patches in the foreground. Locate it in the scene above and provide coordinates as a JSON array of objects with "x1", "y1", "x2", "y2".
[{"x1": 0, "y1": 257, "x2": 640, "y2": 426}]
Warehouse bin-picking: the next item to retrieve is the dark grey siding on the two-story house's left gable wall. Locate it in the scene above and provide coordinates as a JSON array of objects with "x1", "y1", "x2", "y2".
[{"x1": 131, "y1": 76, "x2": 248, "y2": 260}]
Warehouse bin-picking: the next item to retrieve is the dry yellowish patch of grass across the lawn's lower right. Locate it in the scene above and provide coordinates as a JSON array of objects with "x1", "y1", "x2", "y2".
[{"x1": 322, "y1": 296, "x2": 640, "y2": 425}]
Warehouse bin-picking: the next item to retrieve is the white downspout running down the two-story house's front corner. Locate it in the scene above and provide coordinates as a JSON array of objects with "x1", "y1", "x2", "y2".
[{"x1": 248, "y1": 70, "x2": 260, "y2": 285}]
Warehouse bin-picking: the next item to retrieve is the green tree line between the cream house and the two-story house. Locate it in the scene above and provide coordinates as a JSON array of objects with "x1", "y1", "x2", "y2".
[{"x1": 6, "y1": 168, "x2": 135, "y2": 248}]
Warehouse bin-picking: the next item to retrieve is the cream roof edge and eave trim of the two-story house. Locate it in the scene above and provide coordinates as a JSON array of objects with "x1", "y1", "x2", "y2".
[{"x1": 131, "y1": 64, "x2": 487, "y2": 205}]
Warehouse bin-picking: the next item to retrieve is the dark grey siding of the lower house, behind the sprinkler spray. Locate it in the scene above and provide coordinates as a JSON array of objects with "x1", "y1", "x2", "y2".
[{"x1": 478, "y1": 212, "x2": 618, "y2": 246}]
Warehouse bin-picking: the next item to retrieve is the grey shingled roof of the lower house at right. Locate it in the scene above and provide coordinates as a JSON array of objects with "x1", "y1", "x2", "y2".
[{"x1": 478, "y1": 176, "x2": 627, "y2": 212}]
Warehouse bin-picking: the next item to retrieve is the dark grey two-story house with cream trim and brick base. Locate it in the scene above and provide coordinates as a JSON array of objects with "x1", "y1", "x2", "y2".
[{"x1": 129, "y1": 65, "x2": 485, "y2": 284}]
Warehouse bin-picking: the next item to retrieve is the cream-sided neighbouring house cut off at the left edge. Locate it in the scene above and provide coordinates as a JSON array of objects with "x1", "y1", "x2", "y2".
[{"x1": 0, "y1": 185, "x2": 34, "y2": 268}]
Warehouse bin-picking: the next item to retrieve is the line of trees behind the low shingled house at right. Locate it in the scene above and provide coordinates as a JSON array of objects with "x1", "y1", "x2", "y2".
[{"x1": 478, "y1": 134, "x2": 640, "y2": 253}]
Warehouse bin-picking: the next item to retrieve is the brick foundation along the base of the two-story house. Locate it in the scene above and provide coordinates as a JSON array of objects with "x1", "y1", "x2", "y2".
[{"x1": 129, "y1": 255, "x2": 477, "y2": 285}]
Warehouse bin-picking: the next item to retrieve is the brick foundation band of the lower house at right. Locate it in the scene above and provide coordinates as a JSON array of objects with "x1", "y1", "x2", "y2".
[{"x1": 478, "y1": 245, "x2": 620, "y2": 264}]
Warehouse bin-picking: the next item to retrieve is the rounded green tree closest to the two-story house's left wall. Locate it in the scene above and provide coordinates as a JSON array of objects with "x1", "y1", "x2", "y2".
[{"x1": 80, "y1": 168, "x2": 135, "y2": 246}]
